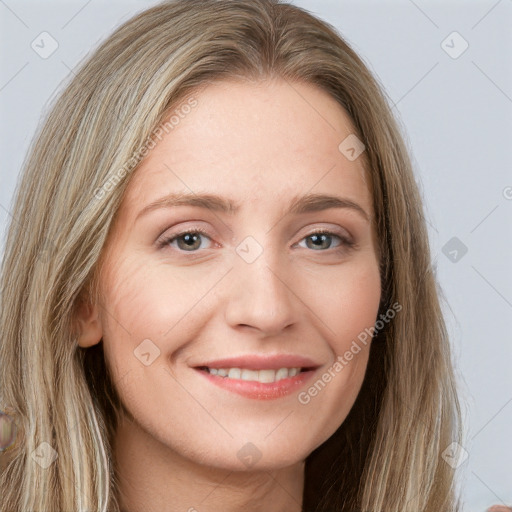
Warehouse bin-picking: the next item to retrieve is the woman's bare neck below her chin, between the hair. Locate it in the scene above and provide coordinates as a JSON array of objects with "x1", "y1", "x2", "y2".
[{"x1": 114, "y1": 416, "x2": 305, "y2": 512}]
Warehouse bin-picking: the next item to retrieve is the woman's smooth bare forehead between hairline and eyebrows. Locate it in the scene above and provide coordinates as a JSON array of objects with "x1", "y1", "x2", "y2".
[{"x1": 125, "y1": 79, "x2": 371, "y2": 215}]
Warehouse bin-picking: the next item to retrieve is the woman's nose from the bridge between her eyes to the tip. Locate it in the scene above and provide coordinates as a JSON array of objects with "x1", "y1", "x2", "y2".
[{"x1": 226, "y1": 237, "x2": 296, "y2": 333}]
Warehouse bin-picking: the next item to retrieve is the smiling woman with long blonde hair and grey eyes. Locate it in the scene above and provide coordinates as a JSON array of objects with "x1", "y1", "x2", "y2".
[{"x1": 0, "y1": 0, "x2": 461, "y2": 512}]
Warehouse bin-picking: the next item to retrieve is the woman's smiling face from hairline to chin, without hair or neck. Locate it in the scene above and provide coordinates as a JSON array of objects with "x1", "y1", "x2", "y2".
[{"x1": 86, "y1": 80, "x2": 381, "y2": 470}]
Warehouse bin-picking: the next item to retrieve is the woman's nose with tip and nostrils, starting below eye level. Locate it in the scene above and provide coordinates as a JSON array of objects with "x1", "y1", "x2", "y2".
[{"x1": 225, "y1": 255, "x2": 300, "y2": 336}]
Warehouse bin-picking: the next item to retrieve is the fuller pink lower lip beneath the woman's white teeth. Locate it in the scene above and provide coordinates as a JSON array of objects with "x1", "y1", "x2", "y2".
[{"x1": 194, "y1": 368, "x2": 315, "y2": 400}]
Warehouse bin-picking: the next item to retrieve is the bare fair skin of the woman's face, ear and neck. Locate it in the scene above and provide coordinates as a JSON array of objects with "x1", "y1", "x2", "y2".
[{"x1": 75, "y1": 79, "x2": 381, "y2": 512}]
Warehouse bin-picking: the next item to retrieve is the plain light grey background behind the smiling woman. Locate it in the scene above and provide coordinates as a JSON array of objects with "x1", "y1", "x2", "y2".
[{"x1": 0, "y1": 0, "x2": 512, "y2": 512}]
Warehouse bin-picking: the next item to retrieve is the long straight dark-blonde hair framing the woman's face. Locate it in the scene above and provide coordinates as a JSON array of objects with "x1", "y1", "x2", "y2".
[{"x1": 0, "y1": 0, "x2": 461, "y2": 512}]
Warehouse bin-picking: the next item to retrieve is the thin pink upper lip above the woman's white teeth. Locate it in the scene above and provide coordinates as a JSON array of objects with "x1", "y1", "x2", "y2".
[{"x1": 194, "y1": 354, "x2": 319, "y2": 370}]
